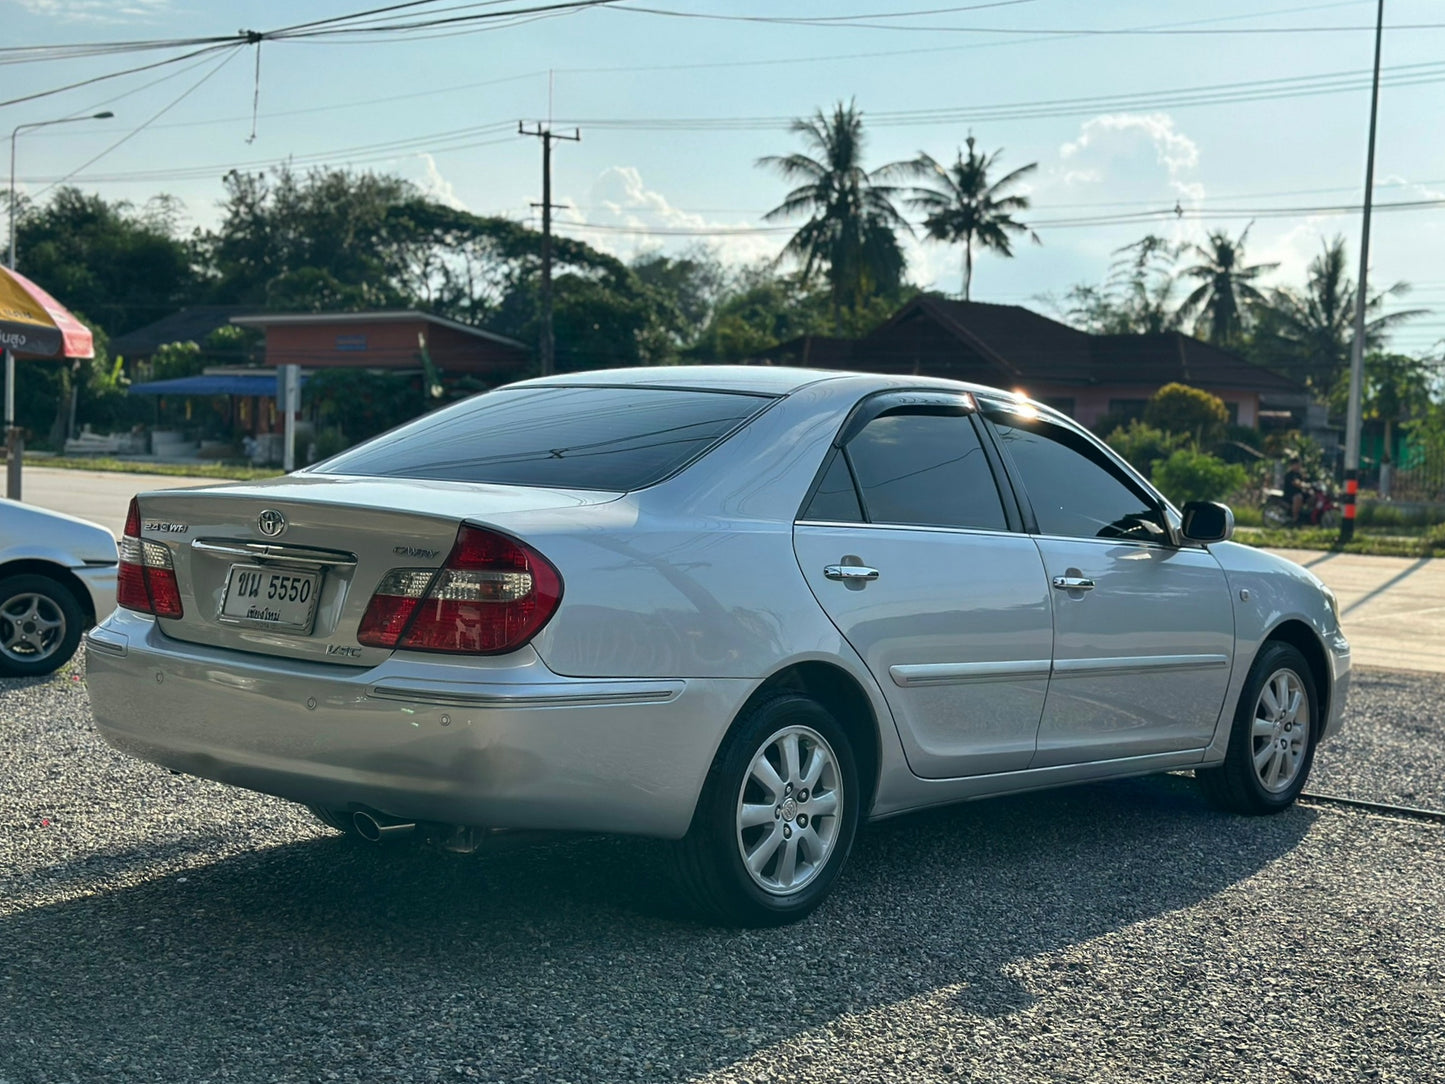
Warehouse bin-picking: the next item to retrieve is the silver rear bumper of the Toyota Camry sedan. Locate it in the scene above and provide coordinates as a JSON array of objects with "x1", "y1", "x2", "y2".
[{"x1": 87, "y1": 610, "x2": 753, "y2": 838}]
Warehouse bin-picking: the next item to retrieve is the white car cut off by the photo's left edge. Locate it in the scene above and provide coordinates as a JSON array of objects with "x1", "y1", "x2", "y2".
[{"x1": 0, "y1": 499, "x2": 118, "y2": 676}]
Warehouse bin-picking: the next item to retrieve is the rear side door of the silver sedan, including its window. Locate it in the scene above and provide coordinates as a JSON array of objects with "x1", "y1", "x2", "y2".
[{"x1": 793, "y1": 393, "x2": 1053, "y2": 779}]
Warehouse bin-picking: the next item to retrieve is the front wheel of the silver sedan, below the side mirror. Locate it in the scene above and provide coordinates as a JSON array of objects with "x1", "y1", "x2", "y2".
[{"x1": 1195, "y1": 642, "x2": 1319, "y2": 814}]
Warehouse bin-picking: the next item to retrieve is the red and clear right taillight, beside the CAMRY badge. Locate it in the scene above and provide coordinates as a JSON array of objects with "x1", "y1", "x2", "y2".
[{"x1": 357, "y1": 523, "x2": 562, "y2": 655}]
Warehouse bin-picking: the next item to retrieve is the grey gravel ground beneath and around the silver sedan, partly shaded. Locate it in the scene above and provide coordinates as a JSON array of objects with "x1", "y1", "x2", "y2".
[{"x1": 0, "y1": 653, "x2": 1445, "y2": 1084}]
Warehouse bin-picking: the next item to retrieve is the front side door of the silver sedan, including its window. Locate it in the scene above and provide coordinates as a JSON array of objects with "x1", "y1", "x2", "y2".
[{"x1": 988, "y1": 409, "x2": 1234, "y2": 767}]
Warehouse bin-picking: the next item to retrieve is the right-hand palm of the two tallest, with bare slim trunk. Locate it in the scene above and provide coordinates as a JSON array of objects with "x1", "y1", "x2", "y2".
[{"x1": 906, "y1": 136, "x2": 1042, "y2": 301}]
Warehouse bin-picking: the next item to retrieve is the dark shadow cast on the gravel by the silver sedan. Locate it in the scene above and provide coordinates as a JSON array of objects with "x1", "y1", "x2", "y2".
[{"x1": 0, "y1": 776, "x2": 1314, "y2": 1084}]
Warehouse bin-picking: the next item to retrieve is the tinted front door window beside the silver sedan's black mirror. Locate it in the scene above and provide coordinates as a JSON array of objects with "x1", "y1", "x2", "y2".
[{"x1": 990, "y1": 413, "x2": 1168, "y2": 542}]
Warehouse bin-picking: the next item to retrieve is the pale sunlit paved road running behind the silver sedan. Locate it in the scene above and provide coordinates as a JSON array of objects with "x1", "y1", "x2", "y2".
[{"x1": 14, "y1": 467, "x2": 1445, "y2": 670}]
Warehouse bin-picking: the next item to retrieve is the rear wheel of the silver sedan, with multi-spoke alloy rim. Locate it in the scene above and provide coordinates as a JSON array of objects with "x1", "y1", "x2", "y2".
[{"x1": 675, "y1": 694, "x2": 861, "y2": 926}]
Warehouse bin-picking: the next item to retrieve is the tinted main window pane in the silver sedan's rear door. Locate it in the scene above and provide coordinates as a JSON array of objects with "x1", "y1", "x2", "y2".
[{"x1": 844, "y1": 410, "x2": 1009, "y2": 530}]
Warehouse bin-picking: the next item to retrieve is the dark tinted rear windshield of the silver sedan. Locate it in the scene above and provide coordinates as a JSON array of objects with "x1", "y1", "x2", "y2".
[{"x1": 314, "y1": 387, "x2": 772, "y2": 490}]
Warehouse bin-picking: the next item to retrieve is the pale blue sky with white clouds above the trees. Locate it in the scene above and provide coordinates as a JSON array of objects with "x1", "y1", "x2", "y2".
[{"x1": 0, "y1": 0, "x2": 1445, "y2": 354}]
